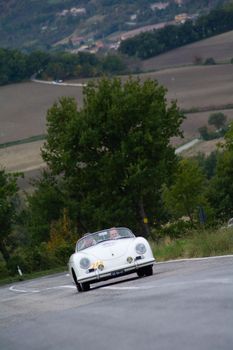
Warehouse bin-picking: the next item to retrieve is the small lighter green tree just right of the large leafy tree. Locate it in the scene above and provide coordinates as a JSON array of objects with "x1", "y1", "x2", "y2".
[{"x1": 163, "y1": 159, "x2": 207, "y2": 225}]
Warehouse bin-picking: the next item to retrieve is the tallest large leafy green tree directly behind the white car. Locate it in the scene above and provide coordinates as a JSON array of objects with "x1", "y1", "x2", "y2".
[{"x1": 42, "y1": 78, "x2": 184, "y2": 235}]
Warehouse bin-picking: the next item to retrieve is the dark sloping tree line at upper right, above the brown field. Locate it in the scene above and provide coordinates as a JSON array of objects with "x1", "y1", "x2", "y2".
[{"x1": 119, "y1": 4, "x2": 233, "y2": 59}]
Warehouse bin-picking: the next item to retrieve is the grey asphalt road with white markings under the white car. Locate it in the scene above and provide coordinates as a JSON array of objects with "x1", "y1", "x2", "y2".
[{"x1": 0, "y1": 257, "x2": 233, "y2": 350}]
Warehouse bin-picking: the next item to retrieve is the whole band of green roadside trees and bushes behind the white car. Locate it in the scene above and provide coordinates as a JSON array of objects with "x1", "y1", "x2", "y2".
[{"x1": 0, "y1": 78, "x2": 233, "y2": 277}]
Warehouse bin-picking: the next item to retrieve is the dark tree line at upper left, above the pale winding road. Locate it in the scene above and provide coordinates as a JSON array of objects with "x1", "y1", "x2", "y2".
[{"x1": 0, "y1": 49, "x2": 127, "y2": 85}]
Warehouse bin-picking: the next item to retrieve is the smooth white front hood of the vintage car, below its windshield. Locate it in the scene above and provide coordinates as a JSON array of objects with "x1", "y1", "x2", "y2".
[{"x1": 85, "y1": 238, "x2": 134, "y2": 260}]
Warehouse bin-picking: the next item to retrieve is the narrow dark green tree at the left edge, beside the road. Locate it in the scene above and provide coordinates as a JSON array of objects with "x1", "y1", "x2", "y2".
[{"x1": 0, "y1": 169, "x2": 19, "y2": 263}]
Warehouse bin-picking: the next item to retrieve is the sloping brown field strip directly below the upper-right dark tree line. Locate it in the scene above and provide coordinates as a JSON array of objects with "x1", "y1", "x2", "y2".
[{"x1": 142, "y1": 31, "x2": 233, "y2": 71}]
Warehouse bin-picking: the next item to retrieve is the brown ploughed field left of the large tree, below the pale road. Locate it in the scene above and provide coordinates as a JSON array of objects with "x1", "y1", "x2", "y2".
[{"x1": 0, "y1": 82, "x2": 82, "y2": 144}]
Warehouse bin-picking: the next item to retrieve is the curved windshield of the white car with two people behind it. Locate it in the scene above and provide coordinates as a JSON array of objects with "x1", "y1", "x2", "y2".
[{"x1": 76, "y1": 227, "x2": 135, "y2": 251}]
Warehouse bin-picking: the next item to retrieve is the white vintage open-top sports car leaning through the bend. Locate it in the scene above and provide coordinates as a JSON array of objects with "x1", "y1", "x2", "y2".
[{"x1": 69, "y1": 227, "x2": 155, "y2": 292}]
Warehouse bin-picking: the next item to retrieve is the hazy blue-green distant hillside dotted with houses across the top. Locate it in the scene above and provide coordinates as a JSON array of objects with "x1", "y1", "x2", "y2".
[{"x1": 0, "y1": 0, "x2": 228, "y2": 50}]
